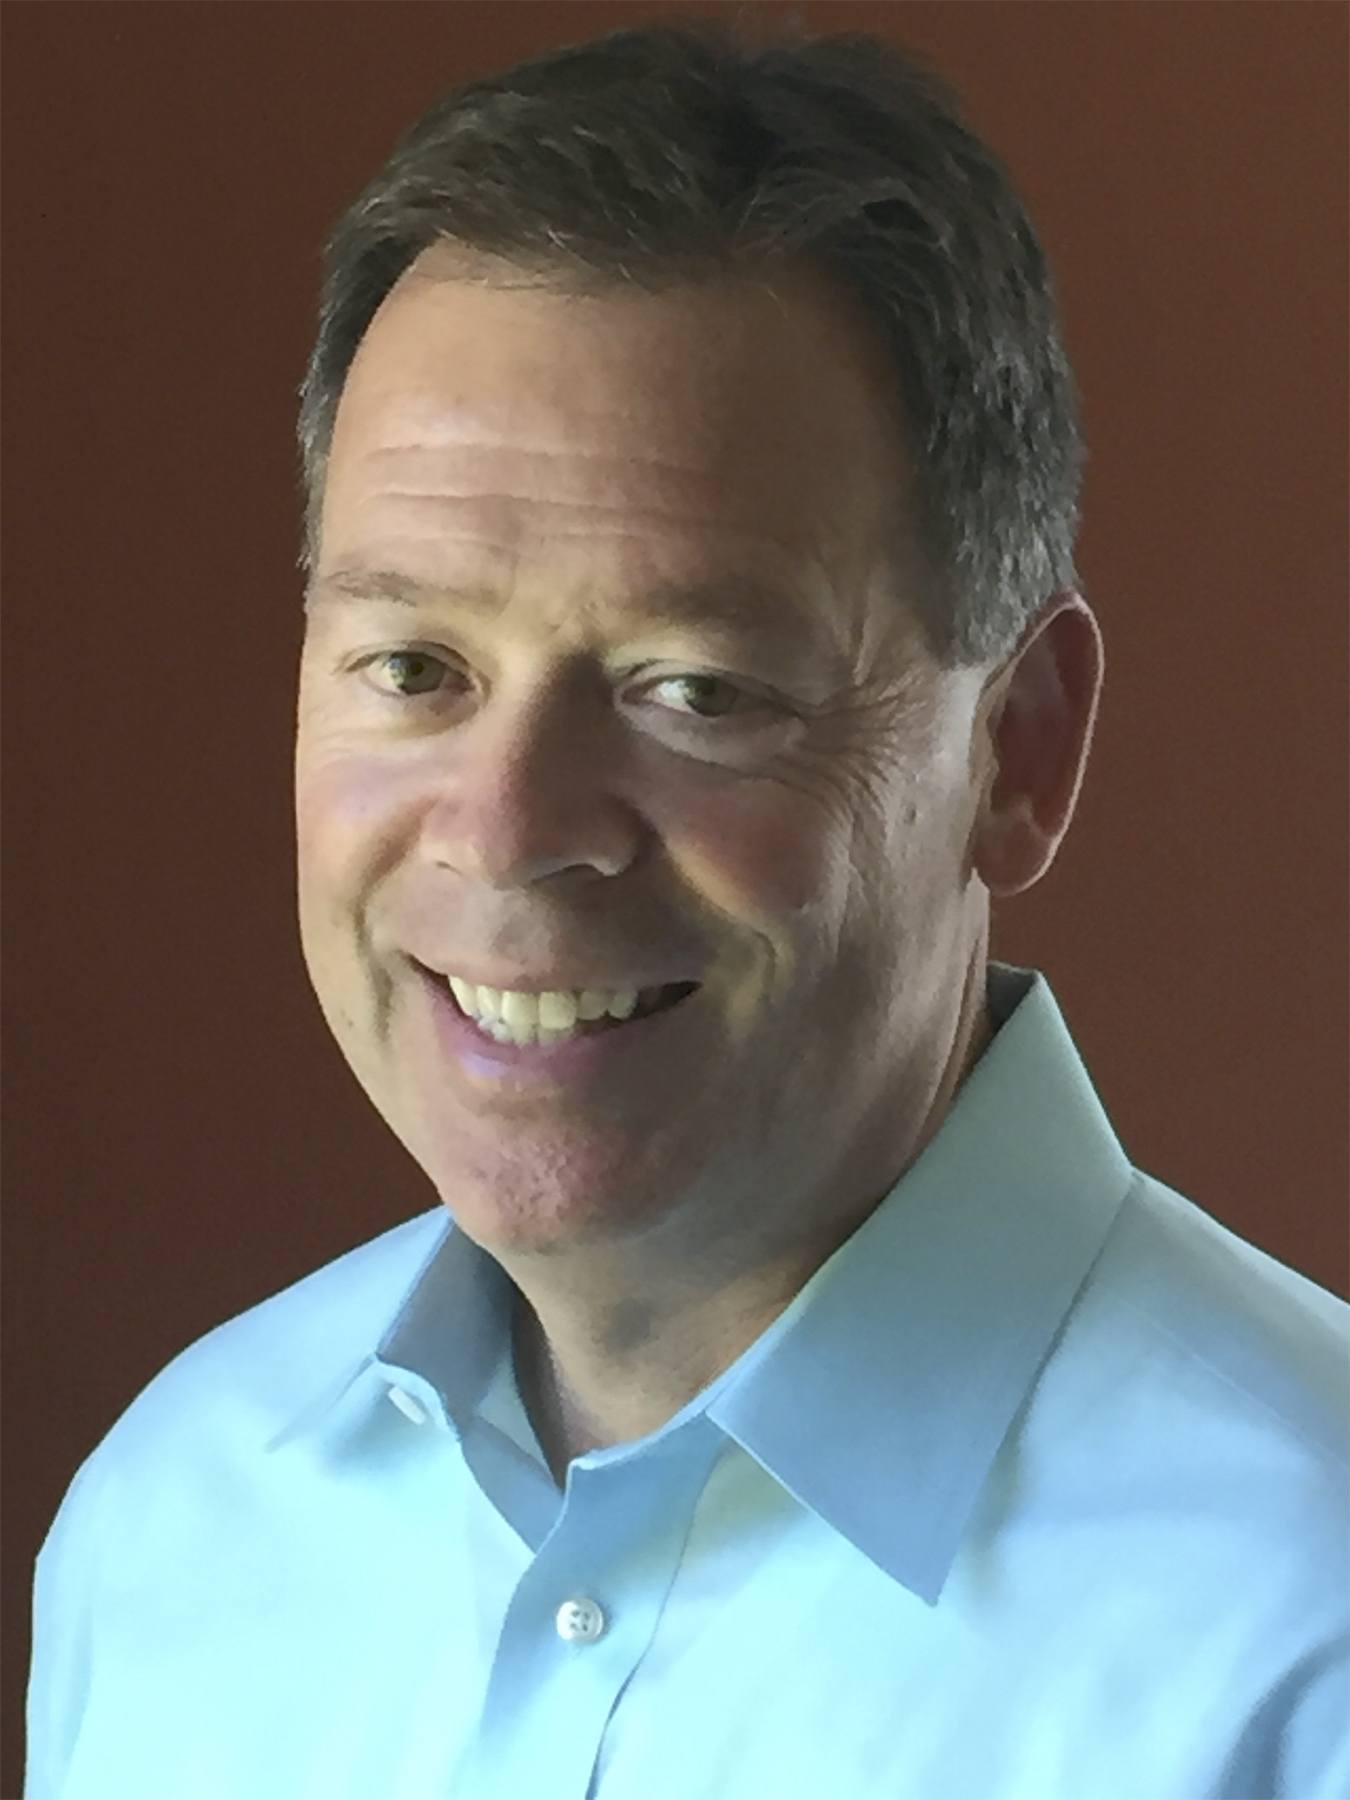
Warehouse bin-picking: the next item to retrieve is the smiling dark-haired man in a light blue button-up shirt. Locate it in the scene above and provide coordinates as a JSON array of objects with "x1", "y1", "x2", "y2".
[{"x1": 29, "y1": 17, "x2": 1350, "y2": 1800}]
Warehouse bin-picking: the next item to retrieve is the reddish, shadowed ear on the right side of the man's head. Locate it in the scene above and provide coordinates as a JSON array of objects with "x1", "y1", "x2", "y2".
[{"x1": 972, "y1": 592, "x2": 1103, "y2": 896}]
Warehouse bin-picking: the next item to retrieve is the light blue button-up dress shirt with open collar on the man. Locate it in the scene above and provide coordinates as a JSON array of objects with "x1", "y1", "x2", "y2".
[{"x1": 27, "y1": 963, "x2": 1350, "y2": 1800}]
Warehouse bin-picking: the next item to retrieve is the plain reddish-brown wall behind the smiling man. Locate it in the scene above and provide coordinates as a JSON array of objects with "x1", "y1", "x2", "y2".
[{"x1": 0, "y1": 0, "x2": 1350, "y2": 1795}]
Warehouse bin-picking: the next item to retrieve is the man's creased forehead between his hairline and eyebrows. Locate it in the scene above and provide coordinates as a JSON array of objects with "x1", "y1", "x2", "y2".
[{"x1": 319, "y1": 252, "x2": 914, "y2": 669}]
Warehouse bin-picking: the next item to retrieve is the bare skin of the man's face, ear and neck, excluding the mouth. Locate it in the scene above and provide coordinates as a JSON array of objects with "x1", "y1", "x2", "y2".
[{"x1": 295, "y1": 248, "x2": 1102, "y2": 1480}]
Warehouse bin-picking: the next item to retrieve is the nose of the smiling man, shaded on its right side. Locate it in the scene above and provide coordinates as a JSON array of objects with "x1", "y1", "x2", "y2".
[{"x1": 423, "y1": 689, "x2": 644, "y2": 889}]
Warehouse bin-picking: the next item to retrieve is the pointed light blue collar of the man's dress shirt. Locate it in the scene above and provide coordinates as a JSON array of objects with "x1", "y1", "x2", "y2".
[{"x1": 284, "y1": 963, "x2": 1132, "y2": 1606}]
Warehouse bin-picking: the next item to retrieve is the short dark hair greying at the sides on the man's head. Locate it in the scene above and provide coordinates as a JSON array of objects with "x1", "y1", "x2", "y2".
[{"x1": 299, "y1": 22, "x2": 1082, "y2": 664}]
